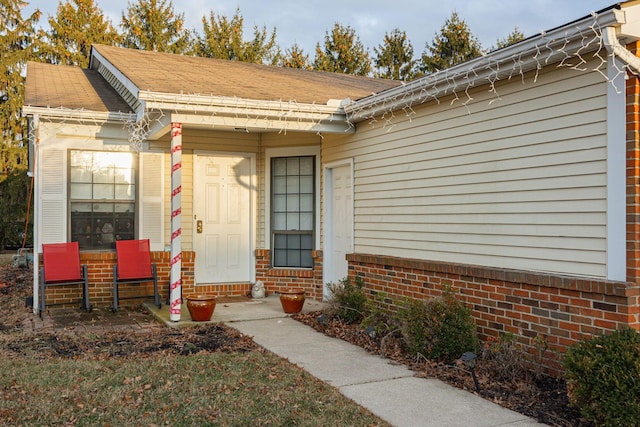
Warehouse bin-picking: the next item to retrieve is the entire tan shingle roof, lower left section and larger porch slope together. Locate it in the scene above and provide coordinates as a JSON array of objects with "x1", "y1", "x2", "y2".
[{"x1": 25, "y1": 45, "x2": 401, "y2": 112}]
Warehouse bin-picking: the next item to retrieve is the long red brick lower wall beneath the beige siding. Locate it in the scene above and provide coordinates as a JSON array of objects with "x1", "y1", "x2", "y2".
[{"x1": 347, "y1": 254, "x2": 640, "y2": 372}]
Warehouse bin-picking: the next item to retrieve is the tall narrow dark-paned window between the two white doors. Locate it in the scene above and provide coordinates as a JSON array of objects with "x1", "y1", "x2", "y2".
[{"x1": 271, "y1": 156, "x2": 315, "y2": 268}]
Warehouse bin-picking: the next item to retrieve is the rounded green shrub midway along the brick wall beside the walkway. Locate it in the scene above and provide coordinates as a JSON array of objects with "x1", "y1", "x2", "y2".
[{"x1": 399, "y1": 287, "x2": 478, "y2": 362}]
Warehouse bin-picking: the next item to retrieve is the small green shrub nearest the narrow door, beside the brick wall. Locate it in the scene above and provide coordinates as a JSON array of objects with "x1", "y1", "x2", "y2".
[{"x1": 325, "y1": 277, "x2": 367, "y2": 323}]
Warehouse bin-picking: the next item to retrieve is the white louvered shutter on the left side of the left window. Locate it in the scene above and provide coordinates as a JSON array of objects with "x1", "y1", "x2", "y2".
[{"x1": 38, "y1": 148, "x2": 67, "y2": 243}]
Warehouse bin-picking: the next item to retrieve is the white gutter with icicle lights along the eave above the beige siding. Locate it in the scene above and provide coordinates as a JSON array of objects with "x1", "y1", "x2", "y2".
[{"x1": 344, "y1": 9, "x2": 624, "y2": 122}]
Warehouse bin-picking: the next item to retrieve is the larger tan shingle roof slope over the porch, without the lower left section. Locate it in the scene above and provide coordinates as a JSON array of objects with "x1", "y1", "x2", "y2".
[{"x1": 93, "y1": 45, "x2": 400, "y2": 104}]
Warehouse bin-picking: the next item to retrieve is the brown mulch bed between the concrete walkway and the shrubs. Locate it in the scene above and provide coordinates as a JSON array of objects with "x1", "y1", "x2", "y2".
[{"x1": 292, "y1": 311, "x2": 592, "y2": 427}]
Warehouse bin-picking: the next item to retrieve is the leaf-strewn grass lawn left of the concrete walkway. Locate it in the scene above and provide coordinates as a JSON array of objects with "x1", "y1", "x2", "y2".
[{"x1": 0, "y1": 351, "x2": 388, "y2": 426}]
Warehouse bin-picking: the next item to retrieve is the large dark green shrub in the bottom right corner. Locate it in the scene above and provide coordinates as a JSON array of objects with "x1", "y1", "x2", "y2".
[{"x1": 563, "y1": 328, "x2": 640, "y2": 426}]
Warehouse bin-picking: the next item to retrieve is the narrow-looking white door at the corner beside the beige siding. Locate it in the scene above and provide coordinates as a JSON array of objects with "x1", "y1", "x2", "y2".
[{"x1": 324, "y1": 164, "x2": 353, "y2": 297}]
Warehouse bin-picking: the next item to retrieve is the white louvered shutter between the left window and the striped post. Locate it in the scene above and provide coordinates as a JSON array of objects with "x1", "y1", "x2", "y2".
[{"x1": 139, "y1": 153, "x2": 164, "y2": 251}]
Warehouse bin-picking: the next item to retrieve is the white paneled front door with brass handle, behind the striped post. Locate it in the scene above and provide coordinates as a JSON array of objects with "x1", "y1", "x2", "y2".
[{"x1": 193, "y1": 155, "x2": 253, "y2": 284}]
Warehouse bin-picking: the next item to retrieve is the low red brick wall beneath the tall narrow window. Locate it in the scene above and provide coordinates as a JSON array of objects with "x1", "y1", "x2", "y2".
[{"x1": 255, "y1": 249, "x2": 322, "y2": 301}]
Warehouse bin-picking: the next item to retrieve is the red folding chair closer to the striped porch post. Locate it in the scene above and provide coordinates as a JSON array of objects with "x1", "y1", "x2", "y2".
[{"x1": 113, "y1": 239, "x2": 162, "y2": 310}]
